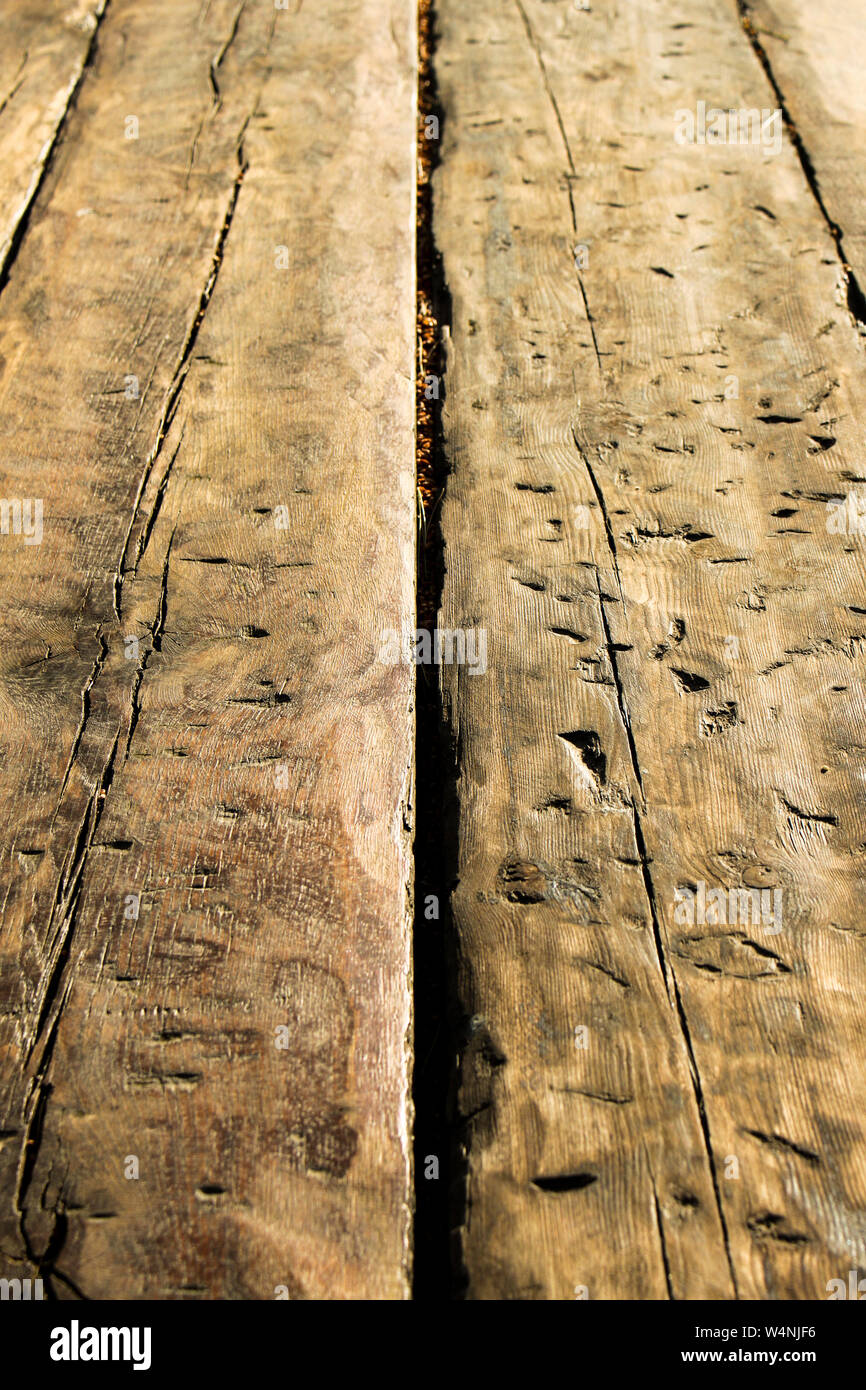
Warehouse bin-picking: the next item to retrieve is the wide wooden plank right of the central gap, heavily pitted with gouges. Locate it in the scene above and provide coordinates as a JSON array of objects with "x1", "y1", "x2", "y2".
[{"x1": 435, "y1": 0, "x2": 866, "y2": 1300}]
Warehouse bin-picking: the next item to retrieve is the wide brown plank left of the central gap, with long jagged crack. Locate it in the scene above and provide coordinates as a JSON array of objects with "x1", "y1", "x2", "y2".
[{"x1": 0, "y1": 0, "x2": 414, "y2": 1298}]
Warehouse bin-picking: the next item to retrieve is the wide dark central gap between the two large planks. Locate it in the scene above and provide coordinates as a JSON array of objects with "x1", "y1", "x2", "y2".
[{"x1": 413, "y1": 0, "x2": 460, "y2": 1302}]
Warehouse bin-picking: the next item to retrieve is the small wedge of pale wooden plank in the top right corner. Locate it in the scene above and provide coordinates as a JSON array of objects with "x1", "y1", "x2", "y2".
[{"x1": 740, "y1": 0, "x2": 866, "y2": 307}]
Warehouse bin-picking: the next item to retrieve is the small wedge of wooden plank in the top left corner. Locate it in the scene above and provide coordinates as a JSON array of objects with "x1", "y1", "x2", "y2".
[{"x1": 0, "y1": 0, "x2": 106, "y2": 282}]
